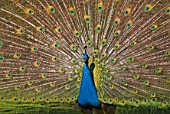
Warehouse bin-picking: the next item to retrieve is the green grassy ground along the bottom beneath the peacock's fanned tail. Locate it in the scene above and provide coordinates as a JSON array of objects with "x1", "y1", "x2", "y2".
[{"x1": 0, "y1": 102, "x2": 170, "y2": 114}]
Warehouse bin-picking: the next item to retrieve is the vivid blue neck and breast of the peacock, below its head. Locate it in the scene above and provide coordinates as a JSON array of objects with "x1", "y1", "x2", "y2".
[{"x1": 78, "y1": 64, "x2": 101, "y2": 107}]
